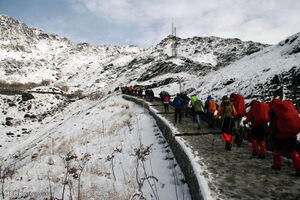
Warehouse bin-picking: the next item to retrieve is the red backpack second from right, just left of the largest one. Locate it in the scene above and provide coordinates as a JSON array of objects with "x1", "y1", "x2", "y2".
[{"x1": 253, "y1": 101, "x2": 270, "y2": 125}]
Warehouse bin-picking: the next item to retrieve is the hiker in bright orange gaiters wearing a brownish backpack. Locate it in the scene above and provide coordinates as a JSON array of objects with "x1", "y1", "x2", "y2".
[{"x1": 215, "y1": 96, "x2": 236, "y2": 151}]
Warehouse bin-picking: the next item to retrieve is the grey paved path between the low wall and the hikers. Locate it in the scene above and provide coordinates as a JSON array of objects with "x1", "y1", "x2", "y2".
[{"x1": 132, "y1": 95, "x2": 300, "y2": 199}]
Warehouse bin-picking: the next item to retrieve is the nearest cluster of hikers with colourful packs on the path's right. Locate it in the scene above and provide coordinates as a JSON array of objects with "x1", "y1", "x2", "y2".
[{"x1": 160, "y1": 91, "x2": 300, "y2": 176}]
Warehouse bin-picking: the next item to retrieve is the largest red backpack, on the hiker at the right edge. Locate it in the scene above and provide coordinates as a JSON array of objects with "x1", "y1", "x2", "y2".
[{"x1": 272, "y1": 100, "x2": 300, "y2": 137}]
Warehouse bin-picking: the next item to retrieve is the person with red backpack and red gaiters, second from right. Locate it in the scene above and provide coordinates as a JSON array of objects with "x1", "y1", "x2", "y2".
[{"x1": 243, "y1": 100, "x2": 270, "y2": 159}]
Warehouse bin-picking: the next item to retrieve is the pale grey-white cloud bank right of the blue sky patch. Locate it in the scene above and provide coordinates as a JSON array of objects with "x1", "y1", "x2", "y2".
[{"x1": 68, "y1": 0, "x2": 300, "y2": 45}]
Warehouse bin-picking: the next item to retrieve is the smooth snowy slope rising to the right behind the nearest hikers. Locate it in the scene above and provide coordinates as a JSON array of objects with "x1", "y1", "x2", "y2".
[{"x1": 177, "y1": 33, "x2": 300, "y2": 109}]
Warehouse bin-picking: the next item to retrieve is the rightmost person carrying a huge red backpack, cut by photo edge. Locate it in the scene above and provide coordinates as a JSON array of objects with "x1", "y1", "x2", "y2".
[{"x1": 269, "y1": 99, "x2": 300, "y2": 176}]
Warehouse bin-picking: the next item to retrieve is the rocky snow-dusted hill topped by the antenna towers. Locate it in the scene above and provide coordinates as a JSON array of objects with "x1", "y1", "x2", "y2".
[{"x1": 116, "y1": 36, "x2": 268, "y2": 90}]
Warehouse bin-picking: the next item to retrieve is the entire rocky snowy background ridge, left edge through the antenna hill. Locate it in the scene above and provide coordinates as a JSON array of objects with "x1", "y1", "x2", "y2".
[{"x1": 0, "y1": 15, "x2": 268, "y2": 92}]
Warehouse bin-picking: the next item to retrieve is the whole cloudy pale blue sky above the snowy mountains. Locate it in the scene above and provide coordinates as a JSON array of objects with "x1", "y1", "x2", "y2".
[{"x1": 0, "y1": 0, "x2": 300, "y2": 47}]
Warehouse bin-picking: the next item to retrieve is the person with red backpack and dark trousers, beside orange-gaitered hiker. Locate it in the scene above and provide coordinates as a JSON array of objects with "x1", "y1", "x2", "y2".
[{"x1": 230, "y1": 93, "x2": 246, "y2": 146}]
